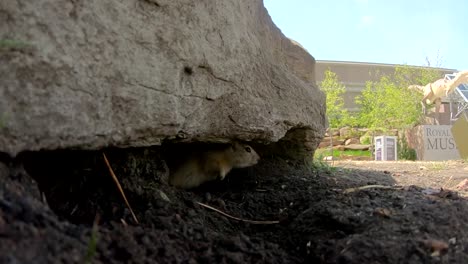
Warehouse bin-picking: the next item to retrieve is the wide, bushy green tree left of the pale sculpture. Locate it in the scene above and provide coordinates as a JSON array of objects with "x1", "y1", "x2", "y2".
[{"x1": 356, "y1": 66, "x2": 441, "y2": 130}]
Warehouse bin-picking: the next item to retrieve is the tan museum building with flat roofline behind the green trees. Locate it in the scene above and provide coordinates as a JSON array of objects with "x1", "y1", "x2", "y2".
[{"x1": 315, "y1": 60, "x2": 457, "y2": 124}]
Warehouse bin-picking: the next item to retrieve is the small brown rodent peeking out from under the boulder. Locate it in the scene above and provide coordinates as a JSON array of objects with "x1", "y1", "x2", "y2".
[{"x1": 169, "y1": 142, "x2": 260, "y2": 189}]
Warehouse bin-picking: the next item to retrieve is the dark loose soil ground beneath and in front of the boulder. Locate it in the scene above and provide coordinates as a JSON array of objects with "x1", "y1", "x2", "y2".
[{"x1": 0, "y1": 149, "x2": 468, "y2": 264}]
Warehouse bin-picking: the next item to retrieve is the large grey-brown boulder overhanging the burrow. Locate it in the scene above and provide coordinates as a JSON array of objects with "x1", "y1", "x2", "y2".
[{"x1": 0, "y1": 0, "x2": 325, "y2": 155}]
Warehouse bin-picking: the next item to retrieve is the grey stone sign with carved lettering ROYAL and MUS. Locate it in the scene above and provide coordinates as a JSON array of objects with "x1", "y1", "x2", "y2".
[{"x1": 410, "y1": 125, "x2": 460, "y2": 160}]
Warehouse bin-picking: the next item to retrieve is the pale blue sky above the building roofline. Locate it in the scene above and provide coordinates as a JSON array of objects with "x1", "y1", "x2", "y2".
[{"x1": 264, "y1": 0, "x2": 468, "y2": 70}]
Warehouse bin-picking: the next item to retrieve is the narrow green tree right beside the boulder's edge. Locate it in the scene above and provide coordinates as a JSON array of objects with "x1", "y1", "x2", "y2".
[{"x1": 320, "y1": 70, "x2": 349, "y2": 128}]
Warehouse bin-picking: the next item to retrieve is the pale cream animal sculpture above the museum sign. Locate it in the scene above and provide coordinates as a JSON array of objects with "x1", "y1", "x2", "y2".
[{"x1": 408, "y1": 70, "x2": 468, "y2": 124}]
